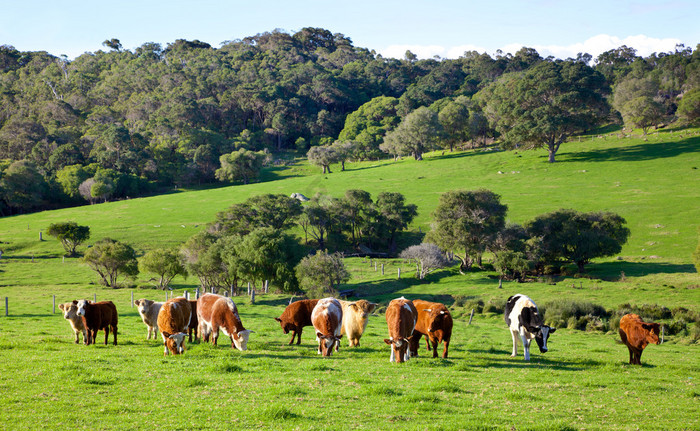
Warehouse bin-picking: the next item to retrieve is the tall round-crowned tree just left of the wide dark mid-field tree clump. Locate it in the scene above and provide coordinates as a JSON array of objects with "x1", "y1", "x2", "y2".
[{"x1": 428, "y1": 189, "x2": 508, "y2": 271}]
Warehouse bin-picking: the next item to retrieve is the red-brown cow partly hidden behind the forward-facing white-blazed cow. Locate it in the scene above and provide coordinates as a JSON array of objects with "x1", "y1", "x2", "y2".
[{"x1": 411, "y1": 299, "x2": 452, "y2": 358}]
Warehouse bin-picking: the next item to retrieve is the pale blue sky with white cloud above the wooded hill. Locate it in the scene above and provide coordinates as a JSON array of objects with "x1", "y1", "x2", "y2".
[{"x1": 0, "y1": 0, "x2": 700, "y2": 59}]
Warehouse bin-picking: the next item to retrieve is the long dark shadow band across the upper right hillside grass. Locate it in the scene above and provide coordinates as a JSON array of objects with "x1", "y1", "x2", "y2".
[{"x1": 559, "y1": 137, "x2": 700, "y2": 163}]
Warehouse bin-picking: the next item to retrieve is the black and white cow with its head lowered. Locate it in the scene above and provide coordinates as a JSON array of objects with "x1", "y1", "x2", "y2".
[{"x1": 505, "y1": 294, "x2": 556, "y2": 361}]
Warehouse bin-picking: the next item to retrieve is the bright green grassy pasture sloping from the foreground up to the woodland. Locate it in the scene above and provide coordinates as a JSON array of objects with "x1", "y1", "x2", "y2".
[{"x1": 0, "y1": 129, "x2": 700, "y2": 430}]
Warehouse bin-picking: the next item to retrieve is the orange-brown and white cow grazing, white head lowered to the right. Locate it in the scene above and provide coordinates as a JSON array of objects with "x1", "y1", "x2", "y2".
[{"x1": 197, "y1": 293, "x2": 253, "y2": 350}]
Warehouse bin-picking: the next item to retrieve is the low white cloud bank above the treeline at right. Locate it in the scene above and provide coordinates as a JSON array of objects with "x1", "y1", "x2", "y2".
[{"x1": 379, "y1": 34, "x2": 681, "y2": 59}]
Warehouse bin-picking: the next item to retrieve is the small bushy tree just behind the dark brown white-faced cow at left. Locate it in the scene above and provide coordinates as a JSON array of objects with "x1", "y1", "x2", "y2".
[{"x1": 83, "y1": 238, "x2": 139, "y2": 288}]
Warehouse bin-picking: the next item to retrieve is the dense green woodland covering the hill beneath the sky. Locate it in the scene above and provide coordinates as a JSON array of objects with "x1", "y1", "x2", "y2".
[{"x1": 0, "y1": 28, "x2": 700, "y2": 215}]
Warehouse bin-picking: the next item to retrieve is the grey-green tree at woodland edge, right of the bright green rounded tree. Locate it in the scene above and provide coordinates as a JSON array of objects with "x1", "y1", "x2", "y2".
[{"x1": 380, "y1": 106, "x2": 443, "y2": 160}]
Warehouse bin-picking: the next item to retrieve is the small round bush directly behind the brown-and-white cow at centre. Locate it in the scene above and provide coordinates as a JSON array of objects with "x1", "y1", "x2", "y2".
[{"x1": 295, "y1": 250, "x2": 350, "y2": 298}]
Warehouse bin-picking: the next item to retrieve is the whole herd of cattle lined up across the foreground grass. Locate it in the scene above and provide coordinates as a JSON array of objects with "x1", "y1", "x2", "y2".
[{"x1": 59, "y1": 293, "x2": 660, "y2": 365}]
